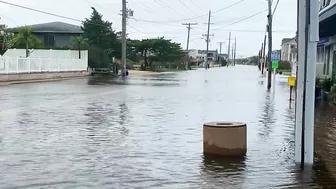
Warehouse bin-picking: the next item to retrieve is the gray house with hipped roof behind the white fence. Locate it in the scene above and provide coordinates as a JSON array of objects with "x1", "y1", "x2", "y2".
[{"x1": 10, "y1": 22, "x2": 84, "y2": 48}]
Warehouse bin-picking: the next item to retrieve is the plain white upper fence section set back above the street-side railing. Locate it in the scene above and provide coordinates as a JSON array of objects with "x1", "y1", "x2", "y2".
[{"x1": 3, "y1": 49, "x2": 88, "y2": 59}]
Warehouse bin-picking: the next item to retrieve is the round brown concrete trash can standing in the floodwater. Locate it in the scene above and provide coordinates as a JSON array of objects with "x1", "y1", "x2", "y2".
[{"x1": 203, "y1": 122, "x2": 247, "y2": 157}]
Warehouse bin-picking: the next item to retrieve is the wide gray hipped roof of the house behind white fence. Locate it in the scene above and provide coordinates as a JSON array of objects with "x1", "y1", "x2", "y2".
[{"x1": 9, "y1": 22, "x2": 83, "y2": 34}]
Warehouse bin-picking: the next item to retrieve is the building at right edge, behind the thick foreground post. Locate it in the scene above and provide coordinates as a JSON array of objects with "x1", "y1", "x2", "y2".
[{"x1": 316, "y1": 0, "x2": 336, "y2": 79}]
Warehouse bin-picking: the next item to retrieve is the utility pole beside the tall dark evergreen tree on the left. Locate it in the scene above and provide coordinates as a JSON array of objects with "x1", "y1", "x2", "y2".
[{"x1": 121, "y1": 0, "x2": 127, "y2": 76}]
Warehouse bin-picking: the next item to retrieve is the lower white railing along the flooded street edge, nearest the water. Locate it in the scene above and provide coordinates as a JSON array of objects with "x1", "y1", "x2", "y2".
[{"x1": 0, "y1": 57, "x2": 88, "y2": 74}]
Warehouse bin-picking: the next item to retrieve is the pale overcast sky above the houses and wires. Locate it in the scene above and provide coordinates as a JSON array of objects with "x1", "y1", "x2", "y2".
[{"x1": 0, "y1": 0, "x2": 297, "y2": 57}]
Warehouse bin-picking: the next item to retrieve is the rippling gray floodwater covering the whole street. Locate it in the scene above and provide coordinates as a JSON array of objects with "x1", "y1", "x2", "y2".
[{"x1": 0, "y1": 66, "x2": 336, "y2": 189}]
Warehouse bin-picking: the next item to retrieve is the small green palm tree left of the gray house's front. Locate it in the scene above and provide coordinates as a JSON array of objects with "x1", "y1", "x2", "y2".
[{"x1": 9, "y1": 27, "x2": 43, "y2": 57}]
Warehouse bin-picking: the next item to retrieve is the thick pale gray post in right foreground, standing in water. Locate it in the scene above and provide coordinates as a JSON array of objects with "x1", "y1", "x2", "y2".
[{"x1": 295, "y1": 0, "x2": 319, "y2": 169}]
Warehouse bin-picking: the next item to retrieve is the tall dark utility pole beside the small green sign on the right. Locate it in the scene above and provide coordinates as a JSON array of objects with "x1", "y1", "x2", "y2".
[{"x1": 267, "y1": 0, "x2": 275, "y2": 89}]
